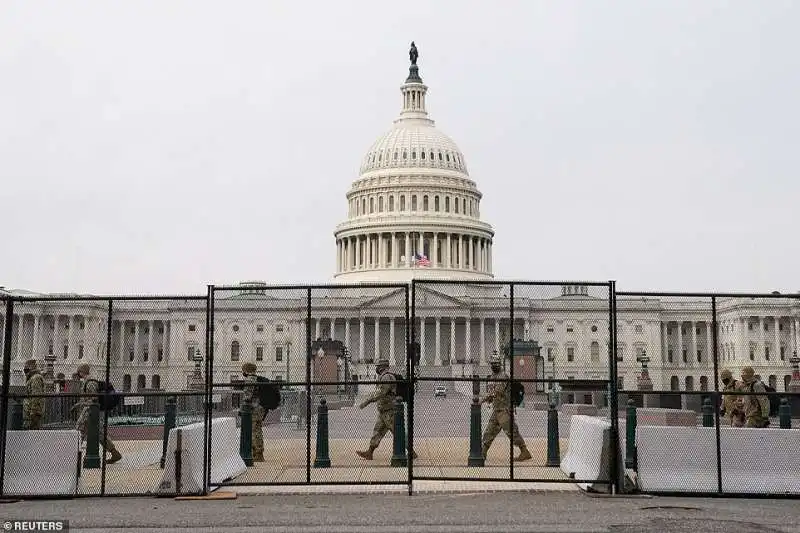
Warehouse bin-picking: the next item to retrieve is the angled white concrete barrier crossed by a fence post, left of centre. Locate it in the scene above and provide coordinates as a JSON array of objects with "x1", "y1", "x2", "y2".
[{"x1": 156, "y1": 417, "x2": 247, "y2": 494}]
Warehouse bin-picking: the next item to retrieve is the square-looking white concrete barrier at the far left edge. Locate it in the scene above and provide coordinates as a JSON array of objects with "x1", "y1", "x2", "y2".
[{"x1": 3, "y1": 429, "x2": 81, "y2": 496}]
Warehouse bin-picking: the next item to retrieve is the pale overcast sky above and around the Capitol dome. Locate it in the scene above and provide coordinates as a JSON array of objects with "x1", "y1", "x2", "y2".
[{"x1": 0, "y1": 0, "x2": 800, "y2": 293}]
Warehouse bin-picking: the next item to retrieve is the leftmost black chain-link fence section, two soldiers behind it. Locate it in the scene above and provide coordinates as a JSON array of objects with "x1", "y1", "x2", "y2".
[{"x1": 0, "y1": 296, "x2": 207, "y2": 496}]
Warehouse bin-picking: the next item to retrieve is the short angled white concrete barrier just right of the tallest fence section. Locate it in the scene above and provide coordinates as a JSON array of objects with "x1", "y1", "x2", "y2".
[{"x1": 561, "y1": 415, "x2": 623, "y2": 492}]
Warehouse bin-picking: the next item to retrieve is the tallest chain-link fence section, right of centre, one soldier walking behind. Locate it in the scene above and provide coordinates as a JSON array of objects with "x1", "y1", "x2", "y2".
[{"x1": 412, "y1": 280, "x2": 616, "y2": 485}]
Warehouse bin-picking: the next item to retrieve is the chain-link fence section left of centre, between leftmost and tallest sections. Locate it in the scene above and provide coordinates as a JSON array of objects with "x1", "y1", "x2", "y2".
[{"x1": 206, "y1": 285, "x2": 409, "y2": 485}]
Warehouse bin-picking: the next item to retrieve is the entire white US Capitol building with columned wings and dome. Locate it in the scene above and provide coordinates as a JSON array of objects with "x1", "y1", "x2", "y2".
[{"x1": 0, "y1": 43, "x2": 800, "y2": 391}]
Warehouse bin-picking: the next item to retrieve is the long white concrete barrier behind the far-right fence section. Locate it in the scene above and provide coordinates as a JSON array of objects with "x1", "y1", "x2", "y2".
[{"x1": 636, "y1": 426, "x2": 800, "y2": 494}]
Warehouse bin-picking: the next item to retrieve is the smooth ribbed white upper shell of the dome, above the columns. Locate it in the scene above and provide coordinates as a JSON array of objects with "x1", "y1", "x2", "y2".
[{"x1": 360, "y1": 121, "x2": 468, "y2": 174}]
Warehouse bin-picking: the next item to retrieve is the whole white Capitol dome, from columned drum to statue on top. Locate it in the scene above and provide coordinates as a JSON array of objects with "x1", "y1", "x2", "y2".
[{"x1": 334, "y1": 43, "x2": 494, "y2": 282}]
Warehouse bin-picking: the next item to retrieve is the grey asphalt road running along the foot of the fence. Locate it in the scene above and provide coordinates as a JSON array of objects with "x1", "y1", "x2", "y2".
[{"x1": 0, "y1": 492, "x2": 800, "y2": 533}]
